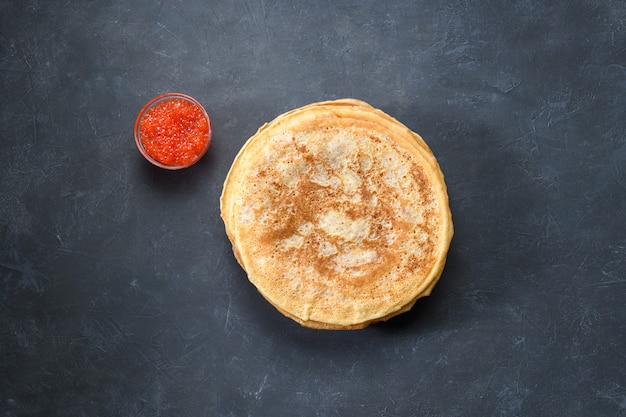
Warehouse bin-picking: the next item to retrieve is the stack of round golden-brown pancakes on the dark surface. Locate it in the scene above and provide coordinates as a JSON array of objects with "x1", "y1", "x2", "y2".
[{"x1": 220, "y1": 99, "x2": 453, "y2": 329}]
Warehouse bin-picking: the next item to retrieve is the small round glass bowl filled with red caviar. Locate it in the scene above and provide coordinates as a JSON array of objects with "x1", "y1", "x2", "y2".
[{"x1": 135, "y1": 94, "x2": 211, "y2": 169}]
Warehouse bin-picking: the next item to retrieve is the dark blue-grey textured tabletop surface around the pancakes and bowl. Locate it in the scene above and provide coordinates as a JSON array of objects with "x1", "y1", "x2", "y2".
[{"x1": 0, "y1": 0, "x2": 626, "y2": 417}]
